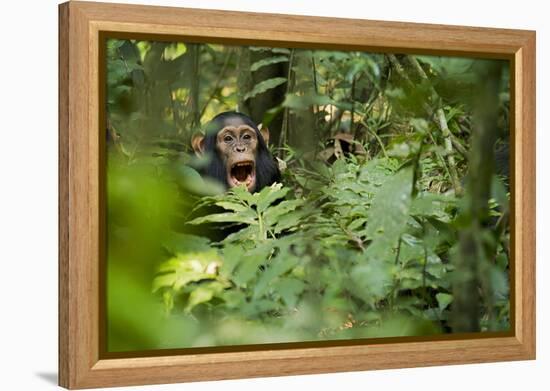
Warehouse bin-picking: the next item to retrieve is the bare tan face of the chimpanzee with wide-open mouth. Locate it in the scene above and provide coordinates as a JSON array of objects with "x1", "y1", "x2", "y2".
[{"x1": 216, "y1": 121, "x2": 258, "y2": 191}]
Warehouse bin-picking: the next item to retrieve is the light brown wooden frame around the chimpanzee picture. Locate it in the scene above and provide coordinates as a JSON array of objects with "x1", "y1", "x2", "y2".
[{"x1": 59, "y1": 1, "x2": 535, "y2": 389}]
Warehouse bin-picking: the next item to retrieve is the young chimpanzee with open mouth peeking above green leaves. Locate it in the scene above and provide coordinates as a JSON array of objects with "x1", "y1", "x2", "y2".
[{"x1": 192, "y1": 111, "x2": 281, "y2": 192}]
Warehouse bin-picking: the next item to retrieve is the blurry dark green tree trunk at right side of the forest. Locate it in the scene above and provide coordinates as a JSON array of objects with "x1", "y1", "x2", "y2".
[{"x1": 450, "y1": 62, "x2": 502, "y2": 332}]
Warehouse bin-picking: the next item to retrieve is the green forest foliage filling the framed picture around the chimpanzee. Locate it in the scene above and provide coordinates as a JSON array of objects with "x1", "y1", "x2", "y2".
[{"x1": 106, "y1": 39, "x2": 510, "y2": 351}]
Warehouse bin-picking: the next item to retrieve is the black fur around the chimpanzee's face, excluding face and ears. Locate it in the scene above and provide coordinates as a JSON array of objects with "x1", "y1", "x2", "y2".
[{"x1": 201, "y1": 111, "x2": 281, "y2": 192}]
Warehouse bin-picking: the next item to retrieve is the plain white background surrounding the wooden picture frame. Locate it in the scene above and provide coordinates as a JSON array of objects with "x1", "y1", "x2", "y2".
[{"x1": 0, "y1": 0, "x2": 550, "y2": 391}]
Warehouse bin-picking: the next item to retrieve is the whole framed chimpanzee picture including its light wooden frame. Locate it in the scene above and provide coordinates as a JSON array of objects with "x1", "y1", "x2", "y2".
[{"x1": 59, "y1": 2, "x2": 535, "y2": 388}]
